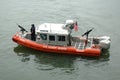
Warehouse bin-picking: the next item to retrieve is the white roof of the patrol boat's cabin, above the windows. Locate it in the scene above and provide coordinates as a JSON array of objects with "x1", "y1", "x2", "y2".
[{"x1": 36, "y1": 23, "x2": 70, "y2": 35}]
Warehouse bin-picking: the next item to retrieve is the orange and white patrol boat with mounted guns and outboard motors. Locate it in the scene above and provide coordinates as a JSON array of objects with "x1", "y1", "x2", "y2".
[{"x1": 12, "y1": 20, "x2": 111, "y2": 57}]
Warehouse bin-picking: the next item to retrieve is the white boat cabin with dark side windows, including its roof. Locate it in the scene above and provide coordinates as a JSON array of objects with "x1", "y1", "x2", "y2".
[{"x1": 36, "y1": 23, "x2": 71, "y2": 46}]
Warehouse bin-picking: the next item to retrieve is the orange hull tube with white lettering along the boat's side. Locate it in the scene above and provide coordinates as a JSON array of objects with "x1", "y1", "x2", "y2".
[{"x1": 12, "y1": 34, "x2": 101, "y2": 57}]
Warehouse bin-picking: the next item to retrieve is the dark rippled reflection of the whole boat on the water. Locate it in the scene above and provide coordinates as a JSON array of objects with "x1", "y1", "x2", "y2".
[{"x1": 14, "y1": 45, "x2": 109, "y2": 73}]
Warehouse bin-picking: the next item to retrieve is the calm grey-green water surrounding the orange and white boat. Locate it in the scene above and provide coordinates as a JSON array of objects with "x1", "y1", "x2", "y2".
[{"x1": 0, "y1": 0, "x2": 120, "y2": 80}]
